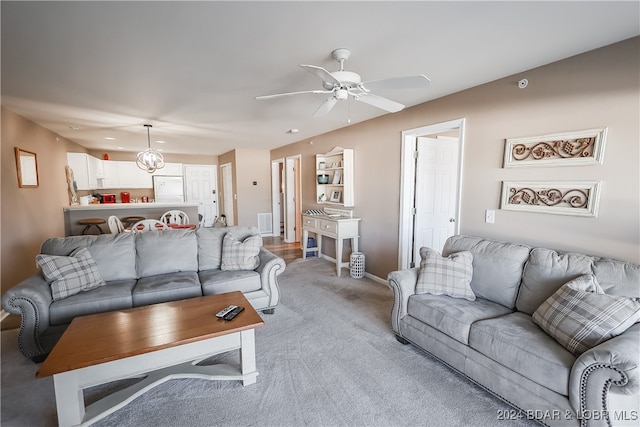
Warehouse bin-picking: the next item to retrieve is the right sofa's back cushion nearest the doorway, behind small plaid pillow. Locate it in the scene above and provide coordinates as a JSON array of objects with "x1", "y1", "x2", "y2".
[{"x1": 442, "y1": 235, "x2": 530, "y2": 309}]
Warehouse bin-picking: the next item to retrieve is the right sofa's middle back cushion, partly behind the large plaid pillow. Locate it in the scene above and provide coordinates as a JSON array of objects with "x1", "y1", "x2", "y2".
[{"x1": 516, "y1": 248, "x2": 595, "y2": 315}]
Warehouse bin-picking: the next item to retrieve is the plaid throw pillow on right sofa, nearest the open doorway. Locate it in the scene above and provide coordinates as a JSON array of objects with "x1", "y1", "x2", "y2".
[{"x1": 416, "y1": 248, "x2": 476, "y2": 301}]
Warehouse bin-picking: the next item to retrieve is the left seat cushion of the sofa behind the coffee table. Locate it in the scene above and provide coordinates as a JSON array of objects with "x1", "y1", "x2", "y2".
[{"x1": 49, "y1": 279, "x2": 136, "y2": 326}]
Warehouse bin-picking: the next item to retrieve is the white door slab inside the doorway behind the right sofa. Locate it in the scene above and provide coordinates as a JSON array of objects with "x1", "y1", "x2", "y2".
[{"x1": 413, "y1": 136, "x2": 459, "y2": 265}]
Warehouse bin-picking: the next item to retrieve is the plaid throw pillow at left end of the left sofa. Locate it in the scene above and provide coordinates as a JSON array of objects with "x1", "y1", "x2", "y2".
[{"x1": 36, "y1": 248, "x2": 106, "y2": 301}]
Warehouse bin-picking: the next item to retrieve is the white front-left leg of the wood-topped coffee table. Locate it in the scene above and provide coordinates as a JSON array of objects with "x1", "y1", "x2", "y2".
[{"x1": 53, "y1": 371, "x2": 84, "y2": 427}]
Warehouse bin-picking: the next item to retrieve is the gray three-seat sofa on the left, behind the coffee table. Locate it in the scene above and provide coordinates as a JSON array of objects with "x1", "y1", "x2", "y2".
[{"x1": 2, "y1": 226, "x2": 285, "y2": 362}]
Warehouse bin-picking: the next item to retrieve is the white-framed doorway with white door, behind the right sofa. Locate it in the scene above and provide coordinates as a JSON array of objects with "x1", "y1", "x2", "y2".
[{"x1": 398, "y1": 119, "x2": 465, "y2": 269}]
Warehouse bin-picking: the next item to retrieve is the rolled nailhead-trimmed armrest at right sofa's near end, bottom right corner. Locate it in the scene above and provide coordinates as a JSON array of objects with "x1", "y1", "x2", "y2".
[{"x1": 569, "y1": 323, "x2": 640, "y2": 425}]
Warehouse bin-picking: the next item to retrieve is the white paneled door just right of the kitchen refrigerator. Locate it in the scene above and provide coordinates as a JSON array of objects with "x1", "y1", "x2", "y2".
[{"x1": 184, "y1": 165, "x2": 218, "y2": 227}]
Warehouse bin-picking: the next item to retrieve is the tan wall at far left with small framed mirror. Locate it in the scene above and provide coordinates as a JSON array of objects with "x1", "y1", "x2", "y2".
[{"x1": 0, "y1": 108, "x2": 86, "y2": 294}]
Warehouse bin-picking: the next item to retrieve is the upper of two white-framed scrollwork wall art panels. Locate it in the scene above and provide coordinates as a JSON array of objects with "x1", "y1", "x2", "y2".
[{"x1": 503, "y1": 128, "x2": 607, "y2": 168}]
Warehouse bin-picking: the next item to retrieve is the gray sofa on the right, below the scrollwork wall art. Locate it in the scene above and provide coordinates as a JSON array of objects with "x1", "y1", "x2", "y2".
[{"x1": 388, "y1": 236, "x2": 640, "y2": 426}]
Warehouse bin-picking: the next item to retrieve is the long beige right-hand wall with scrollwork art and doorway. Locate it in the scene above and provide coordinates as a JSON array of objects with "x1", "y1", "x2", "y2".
[{"x1": 271, "y1": 38, "x2": 640, "y2": 278}]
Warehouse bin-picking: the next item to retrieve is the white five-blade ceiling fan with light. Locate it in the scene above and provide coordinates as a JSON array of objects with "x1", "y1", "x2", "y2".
[{"x1": 256, "y1": 48, "x2": 430, "y2": 117}]
